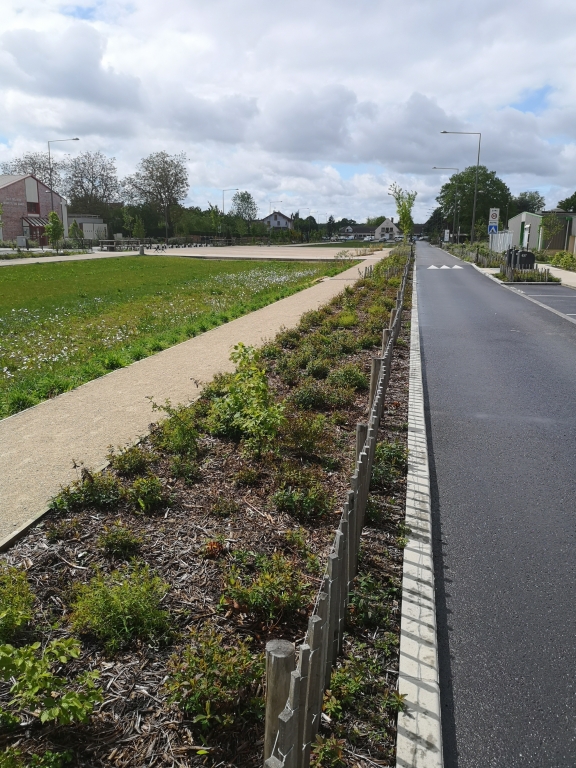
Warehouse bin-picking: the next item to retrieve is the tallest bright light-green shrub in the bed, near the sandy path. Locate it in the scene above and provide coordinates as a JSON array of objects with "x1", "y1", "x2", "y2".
[{"x1": 208, "y1": 344, "x2": 284, "y2": 456}]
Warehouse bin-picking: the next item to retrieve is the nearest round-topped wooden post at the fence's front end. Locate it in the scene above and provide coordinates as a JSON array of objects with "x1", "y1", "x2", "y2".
[{"x1": 264, "y1": 640, "x2": 295, "y2": 761}]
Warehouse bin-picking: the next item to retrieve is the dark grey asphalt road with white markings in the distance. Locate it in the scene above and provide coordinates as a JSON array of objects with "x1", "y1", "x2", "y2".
[{"x1": 417, "y1": 243, "x2": 576, "y2": 768}]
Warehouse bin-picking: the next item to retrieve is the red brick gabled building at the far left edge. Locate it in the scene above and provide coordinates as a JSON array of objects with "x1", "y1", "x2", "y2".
[{"x1": 0, "y1": 173, "x2": 68, "y2": 245}]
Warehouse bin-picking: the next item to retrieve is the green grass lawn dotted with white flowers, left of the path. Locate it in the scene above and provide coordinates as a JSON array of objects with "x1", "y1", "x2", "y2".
[{"x1": 0, "y1": 256, "x2": 354, "y2": 418}]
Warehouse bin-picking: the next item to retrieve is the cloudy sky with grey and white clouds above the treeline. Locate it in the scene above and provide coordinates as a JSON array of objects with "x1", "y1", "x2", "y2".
[{"x1": 0, "y1": 0, "x2": 576, "y2": 221}]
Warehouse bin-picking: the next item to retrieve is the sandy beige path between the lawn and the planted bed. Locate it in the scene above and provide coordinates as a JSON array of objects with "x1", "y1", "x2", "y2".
[{"x1": 0, "y1": 253, "x2": 382, "y2": 546}]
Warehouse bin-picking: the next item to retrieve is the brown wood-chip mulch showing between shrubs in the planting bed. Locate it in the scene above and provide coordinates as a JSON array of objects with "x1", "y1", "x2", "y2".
[{"x1": 0, "y1": 255, "x2": 410, "y2": 768}]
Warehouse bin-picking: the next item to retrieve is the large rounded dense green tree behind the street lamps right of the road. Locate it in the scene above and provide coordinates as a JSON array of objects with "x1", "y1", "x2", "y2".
[{"x1": 436, "y1": 165, "x2": 512, "y2": 236}]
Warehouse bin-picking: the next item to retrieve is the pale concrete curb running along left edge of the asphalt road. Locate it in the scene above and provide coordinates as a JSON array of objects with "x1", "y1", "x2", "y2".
[{"x1": 396, "y1": 262, "x2": 444, "y2": 768}]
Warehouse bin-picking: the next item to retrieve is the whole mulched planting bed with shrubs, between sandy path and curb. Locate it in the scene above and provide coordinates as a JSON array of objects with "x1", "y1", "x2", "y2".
[{"x1": 0, "y1": 249, "x2": 409, "y2": 768}]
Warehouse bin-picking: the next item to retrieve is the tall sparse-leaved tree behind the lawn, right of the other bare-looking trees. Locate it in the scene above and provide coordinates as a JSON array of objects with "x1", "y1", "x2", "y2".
[{"x1": 122, "y1": 152, "x2": 188, "y2": 240}]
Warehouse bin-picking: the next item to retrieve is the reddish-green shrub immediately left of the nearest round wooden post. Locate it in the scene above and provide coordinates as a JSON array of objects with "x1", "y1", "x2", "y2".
[{"x1": 166, "y1": 627, "x2": 264, "y2": 730}]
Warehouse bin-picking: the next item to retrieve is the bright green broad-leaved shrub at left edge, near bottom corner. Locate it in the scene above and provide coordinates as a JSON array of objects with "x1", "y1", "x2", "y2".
[{"x1": 0, "y1": 639, "x2": 102, "y2": 725}]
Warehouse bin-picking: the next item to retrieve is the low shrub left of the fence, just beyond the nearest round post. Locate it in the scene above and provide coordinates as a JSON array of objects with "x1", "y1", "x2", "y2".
[{"x1": 220, "y1": 552, "x2": 308, "y2": 621}]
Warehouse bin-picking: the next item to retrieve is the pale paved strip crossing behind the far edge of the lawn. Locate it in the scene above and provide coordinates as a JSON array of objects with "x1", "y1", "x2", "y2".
[{"x1": 0, "y1": 248, "x2": 374, "y2": 267}]
